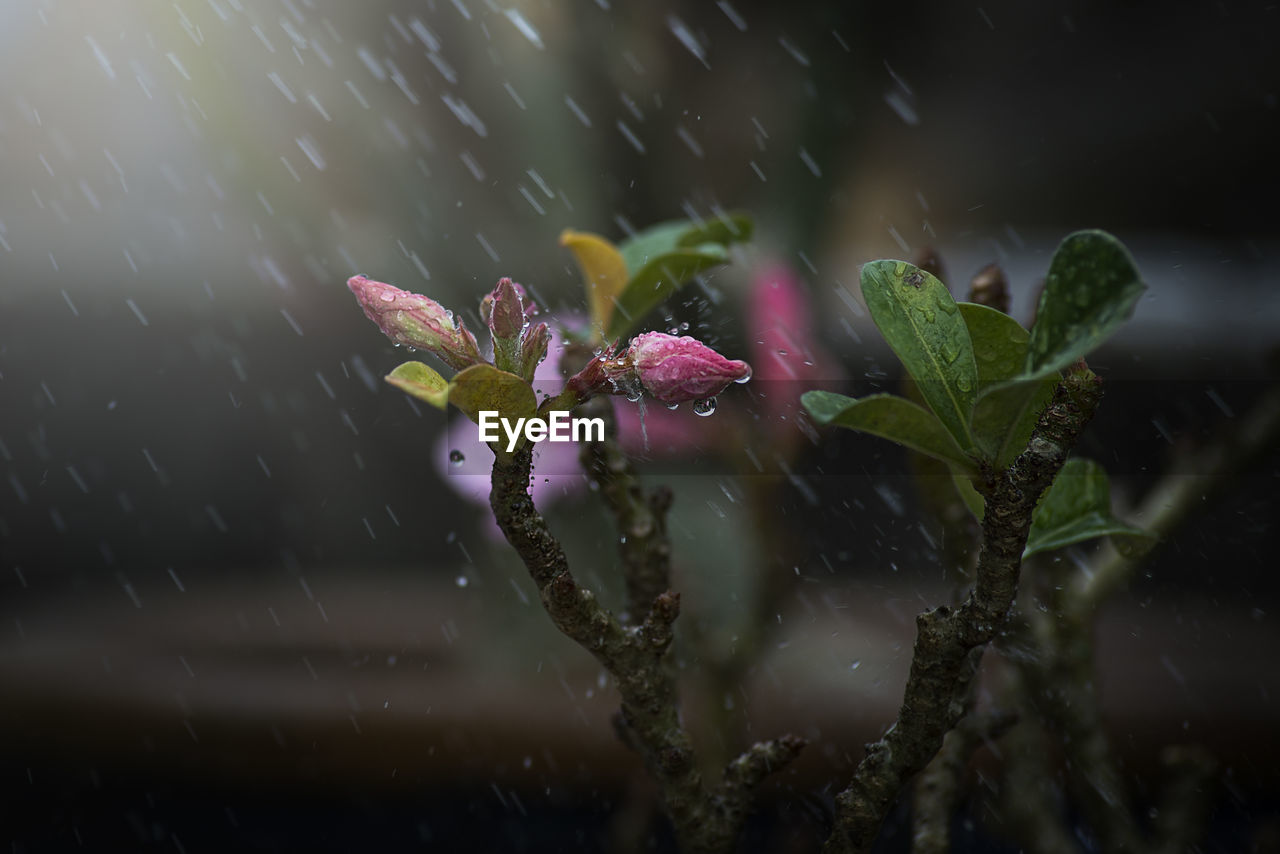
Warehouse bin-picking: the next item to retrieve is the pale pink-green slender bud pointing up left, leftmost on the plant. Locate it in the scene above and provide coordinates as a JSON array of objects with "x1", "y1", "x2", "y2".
[{"x1": 347, "y1": 275, "x2": 483, "y2": 370}]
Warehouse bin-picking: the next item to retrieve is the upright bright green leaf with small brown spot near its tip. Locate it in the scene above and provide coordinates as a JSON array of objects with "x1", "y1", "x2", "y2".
[{"x1": 861, "y1": 261, "x2": 978, "y2": 451}]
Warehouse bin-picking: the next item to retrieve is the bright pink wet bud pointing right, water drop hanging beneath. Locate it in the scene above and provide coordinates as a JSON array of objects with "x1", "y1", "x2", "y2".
[{"x1": 621, "y1": 332, "x2": 751, "y2": 403}]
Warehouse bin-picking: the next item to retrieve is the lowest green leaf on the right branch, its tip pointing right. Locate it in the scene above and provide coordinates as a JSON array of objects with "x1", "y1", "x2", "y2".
[{"x1": 1023, "y1": 457, "x2": 1152, "y2": 560}]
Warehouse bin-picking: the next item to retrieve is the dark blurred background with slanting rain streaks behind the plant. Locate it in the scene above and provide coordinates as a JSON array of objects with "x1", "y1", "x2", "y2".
[{"x1": 0, "y1": 0, "x2": 1280, "y2": 850}]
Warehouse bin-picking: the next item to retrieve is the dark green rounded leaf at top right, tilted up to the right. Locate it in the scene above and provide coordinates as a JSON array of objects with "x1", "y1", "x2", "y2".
[{"x1": 1023, "y1": 230, "x2": 1147, "y2": 379}]
